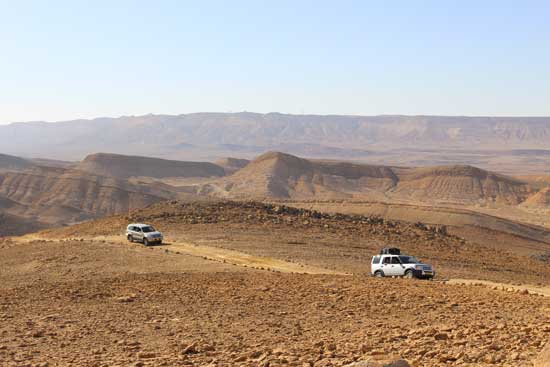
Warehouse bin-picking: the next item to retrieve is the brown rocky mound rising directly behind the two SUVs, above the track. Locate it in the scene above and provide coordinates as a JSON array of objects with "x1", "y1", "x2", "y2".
[{"x1": 43, "y1": 201, "x2": 550, "y2": 285}]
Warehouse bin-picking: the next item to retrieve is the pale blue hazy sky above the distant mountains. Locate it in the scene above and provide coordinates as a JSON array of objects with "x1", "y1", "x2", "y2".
[{"x1": 0, "y1": 0, "x2": 550, "y2": 123}]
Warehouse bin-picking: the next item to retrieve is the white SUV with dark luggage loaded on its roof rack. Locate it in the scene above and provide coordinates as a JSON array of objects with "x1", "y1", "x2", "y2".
[{"x1": 371, "y1": 254, "x2": 435, "y2": 279}]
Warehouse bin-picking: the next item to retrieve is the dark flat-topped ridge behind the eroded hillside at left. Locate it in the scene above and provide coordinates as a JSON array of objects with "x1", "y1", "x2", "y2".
[{"x1": 76, "y1": 153, "x2": 225, "y2": 178}]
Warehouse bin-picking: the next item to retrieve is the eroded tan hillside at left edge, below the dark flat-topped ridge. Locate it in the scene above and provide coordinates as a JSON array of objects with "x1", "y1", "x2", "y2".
[{"x1": 0, "y1": 167, "x2": 174, "y2": 224}]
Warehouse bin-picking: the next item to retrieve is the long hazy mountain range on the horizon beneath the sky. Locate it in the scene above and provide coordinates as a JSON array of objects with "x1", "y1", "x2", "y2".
[{"x1": 0, "y1": 112, "x2": 550, "y2": 160}]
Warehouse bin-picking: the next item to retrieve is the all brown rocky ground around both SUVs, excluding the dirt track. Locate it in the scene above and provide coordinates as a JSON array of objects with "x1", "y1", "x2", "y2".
[{"x1": 0, "y1": 202, "x2": 550, "y2": 367}]
